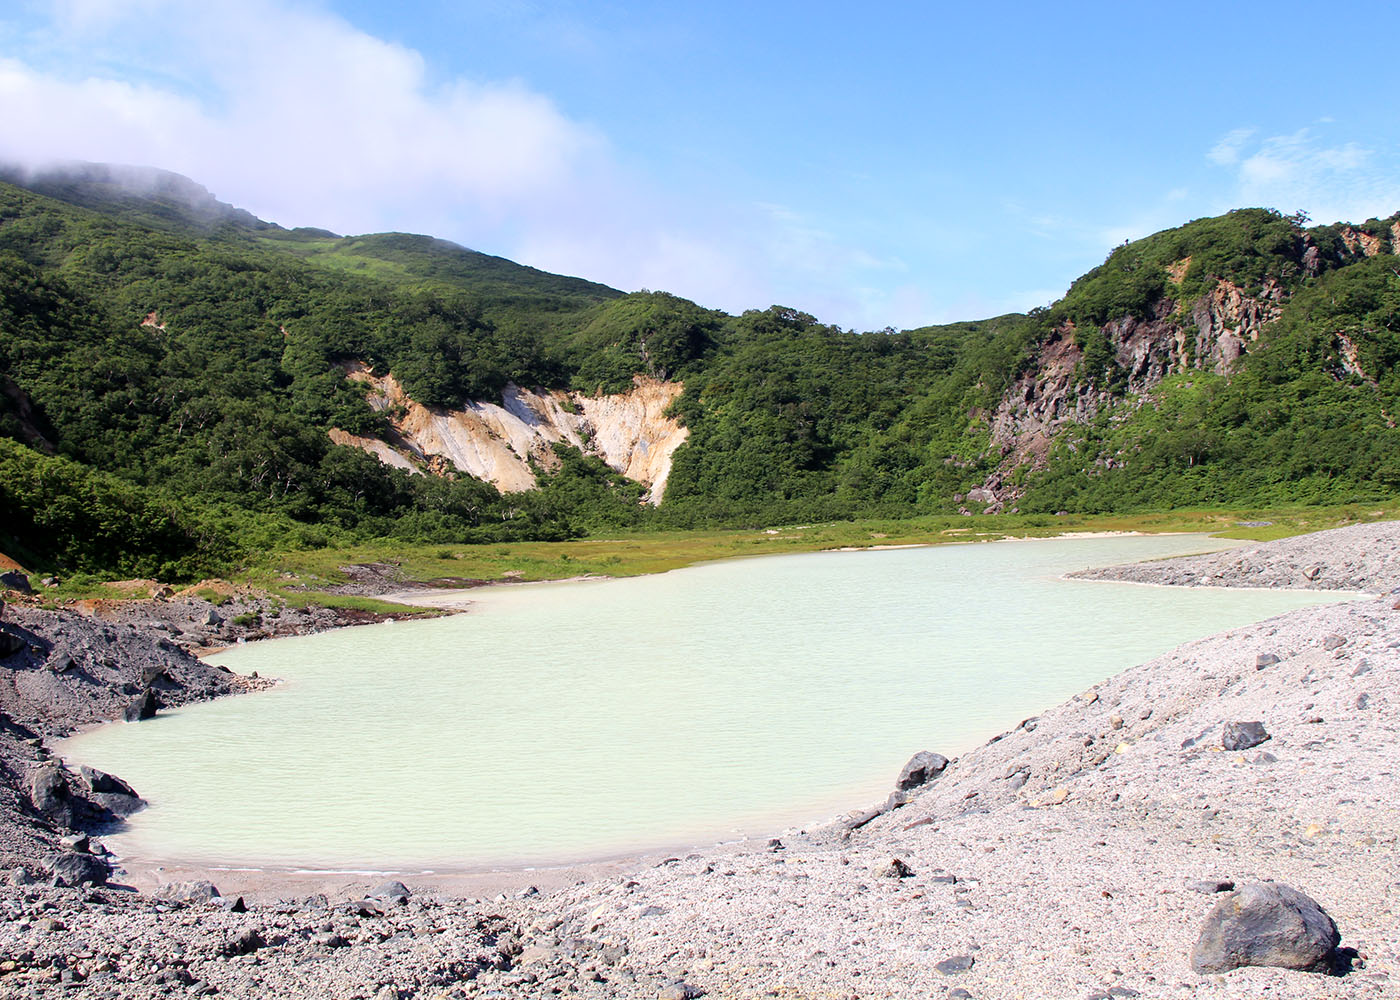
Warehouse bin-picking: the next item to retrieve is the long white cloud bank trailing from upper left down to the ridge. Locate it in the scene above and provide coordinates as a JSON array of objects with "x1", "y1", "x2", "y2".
[{"x1": 0, "y1": 0, "x2": 940, "y2": 328}]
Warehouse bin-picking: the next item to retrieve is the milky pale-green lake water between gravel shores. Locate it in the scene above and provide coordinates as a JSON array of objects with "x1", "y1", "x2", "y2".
[{"x1": 63, "y1": 535, "x2": 1336, "y2": 870}]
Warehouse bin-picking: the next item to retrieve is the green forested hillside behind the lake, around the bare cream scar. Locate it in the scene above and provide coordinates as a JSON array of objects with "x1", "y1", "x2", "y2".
[{"x1": 0, "y1": 167, "x2": 1400, "y2": 576}]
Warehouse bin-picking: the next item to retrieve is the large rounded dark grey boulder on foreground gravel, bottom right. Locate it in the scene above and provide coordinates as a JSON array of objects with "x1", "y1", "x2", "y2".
[{"x1": 1191, "y1": 882, "x2": 1341, "y2": 975}]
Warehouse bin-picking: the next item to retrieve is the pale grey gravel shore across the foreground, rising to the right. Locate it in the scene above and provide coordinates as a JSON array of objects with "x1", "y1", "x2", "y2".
[{"x1": 0, "y1": 525, "x2": 1400, "y2": 1000}]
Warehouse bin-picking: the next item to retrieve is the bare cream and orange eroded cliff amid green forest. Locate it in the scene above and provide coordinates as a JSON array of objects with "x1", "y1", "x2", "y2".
[{"x1": 330, "y1": 364, "x2": 689, "y2": 504}]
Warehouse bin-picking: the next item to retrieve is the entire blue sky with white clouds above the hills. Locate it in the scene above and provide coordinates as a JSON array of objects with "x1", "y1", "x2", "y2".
[{"x1": 0, "y1": 0, "x2": 1400, "y2": 329}]
